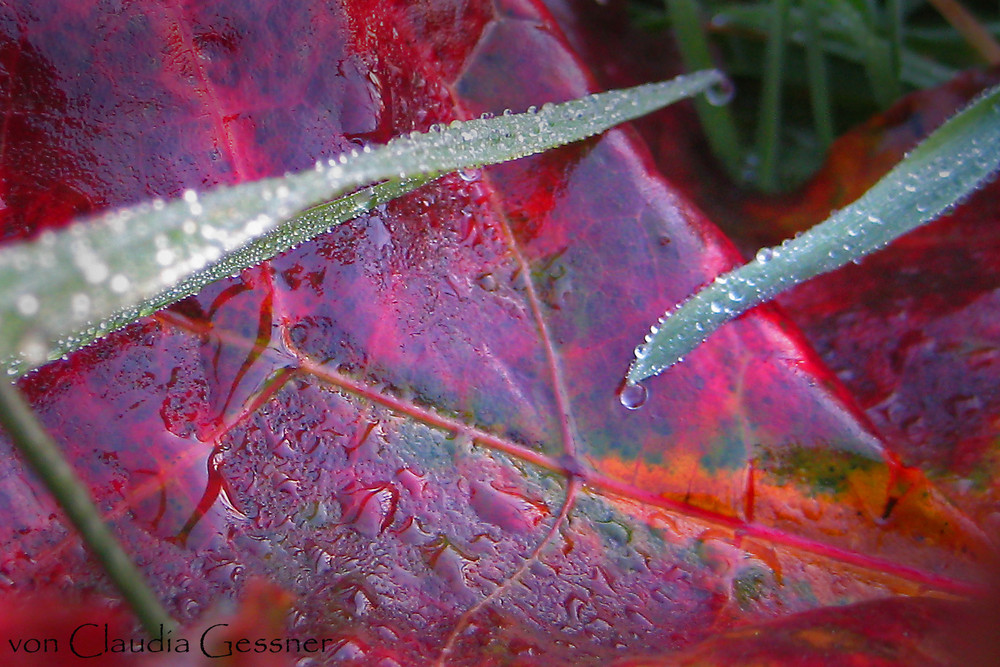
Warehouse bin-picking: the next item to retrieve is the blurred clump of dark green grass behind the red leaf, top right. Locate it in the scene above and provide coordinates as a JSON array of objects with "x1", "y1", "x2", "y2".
[{"x1": 630, "y1": 0, "x2": 997, "y2": 192}]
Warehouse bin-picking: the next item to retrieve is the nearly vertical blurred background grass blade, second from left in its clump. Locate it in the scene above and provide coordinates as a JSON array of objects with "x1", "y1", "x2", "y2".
[{"x1": 756, "y1": 0, "x2": 790, "y2": 191}]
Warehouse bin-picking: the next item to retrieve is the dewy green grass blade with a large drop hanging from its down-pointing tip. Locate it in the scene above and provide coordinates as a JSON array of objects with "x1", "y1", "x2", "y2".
[{"x1": 626, "y1": 86, "x2": 1000, "y2": 385}]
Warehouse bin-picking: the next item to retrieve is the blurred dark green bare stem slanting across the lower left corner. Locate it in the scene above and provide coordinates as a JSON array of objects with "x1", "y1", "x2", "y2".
[{"x1": 0, "y1": 381, "x2": 176, "y2": 636}]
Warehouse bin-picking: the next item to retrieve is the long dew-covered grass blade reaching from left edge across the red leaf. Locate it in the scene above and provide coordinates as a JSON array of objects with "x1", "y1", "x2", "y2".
[{"x1": 0, "y1": 71, "x2": 725, "y2": 376}]
